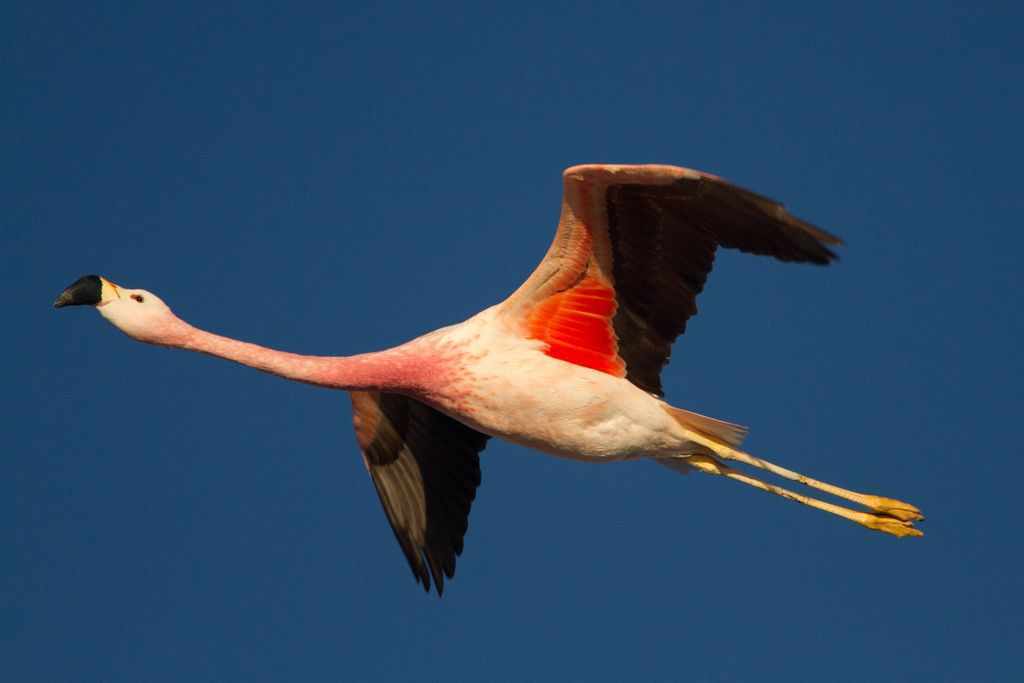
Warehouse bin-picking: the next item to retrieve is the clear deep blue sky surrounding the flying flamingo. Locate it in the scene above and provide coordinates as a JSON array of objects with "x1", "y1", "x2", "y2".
[{"x1": 0, "y1": 2, "x2": 1024, "y2": 682}]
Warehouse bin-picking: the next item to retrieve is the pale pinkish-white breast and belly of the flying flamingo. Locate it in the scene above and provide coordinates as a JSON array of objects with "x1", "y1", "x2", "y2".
[{"x1": 414, "y1": 308, "x2": 686, "y2": 460}]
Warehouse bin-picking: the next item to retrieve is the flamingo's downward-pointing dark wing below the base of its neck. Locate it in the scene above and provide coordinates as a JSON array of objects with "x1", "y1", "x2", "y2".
[{"x1": 349, "y1": 391, "x2": 488, "y2": 595}]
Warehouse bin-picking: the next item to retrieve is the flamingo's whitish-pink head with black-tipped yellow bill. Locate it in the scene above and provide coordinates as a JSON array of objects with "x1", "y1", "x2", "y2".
[{"x1": 53, "y1": 275, "x2": 187, "y2": 345}]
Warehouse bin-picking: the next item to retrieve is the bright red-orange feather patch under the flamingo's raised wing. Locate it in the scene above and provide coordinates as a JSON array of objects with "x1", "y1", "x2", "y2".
[{"x1": 526, "y1": 275, "x2": 626, "y2": 377}]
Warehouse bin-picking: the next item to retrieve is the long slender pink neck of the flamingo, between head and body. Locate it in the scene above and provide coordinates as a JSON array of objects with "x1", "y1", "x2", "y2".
[{"x1": 174, "y1": 326, "x2": 429, "y2": 392}]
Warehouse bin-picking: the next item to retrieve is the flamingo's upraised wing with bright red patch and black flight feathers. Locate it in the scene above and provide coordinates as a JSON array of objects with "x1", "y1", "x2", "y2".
[{"x1": 502, "y1": 165, "x2": 842, "y2": 395}]
